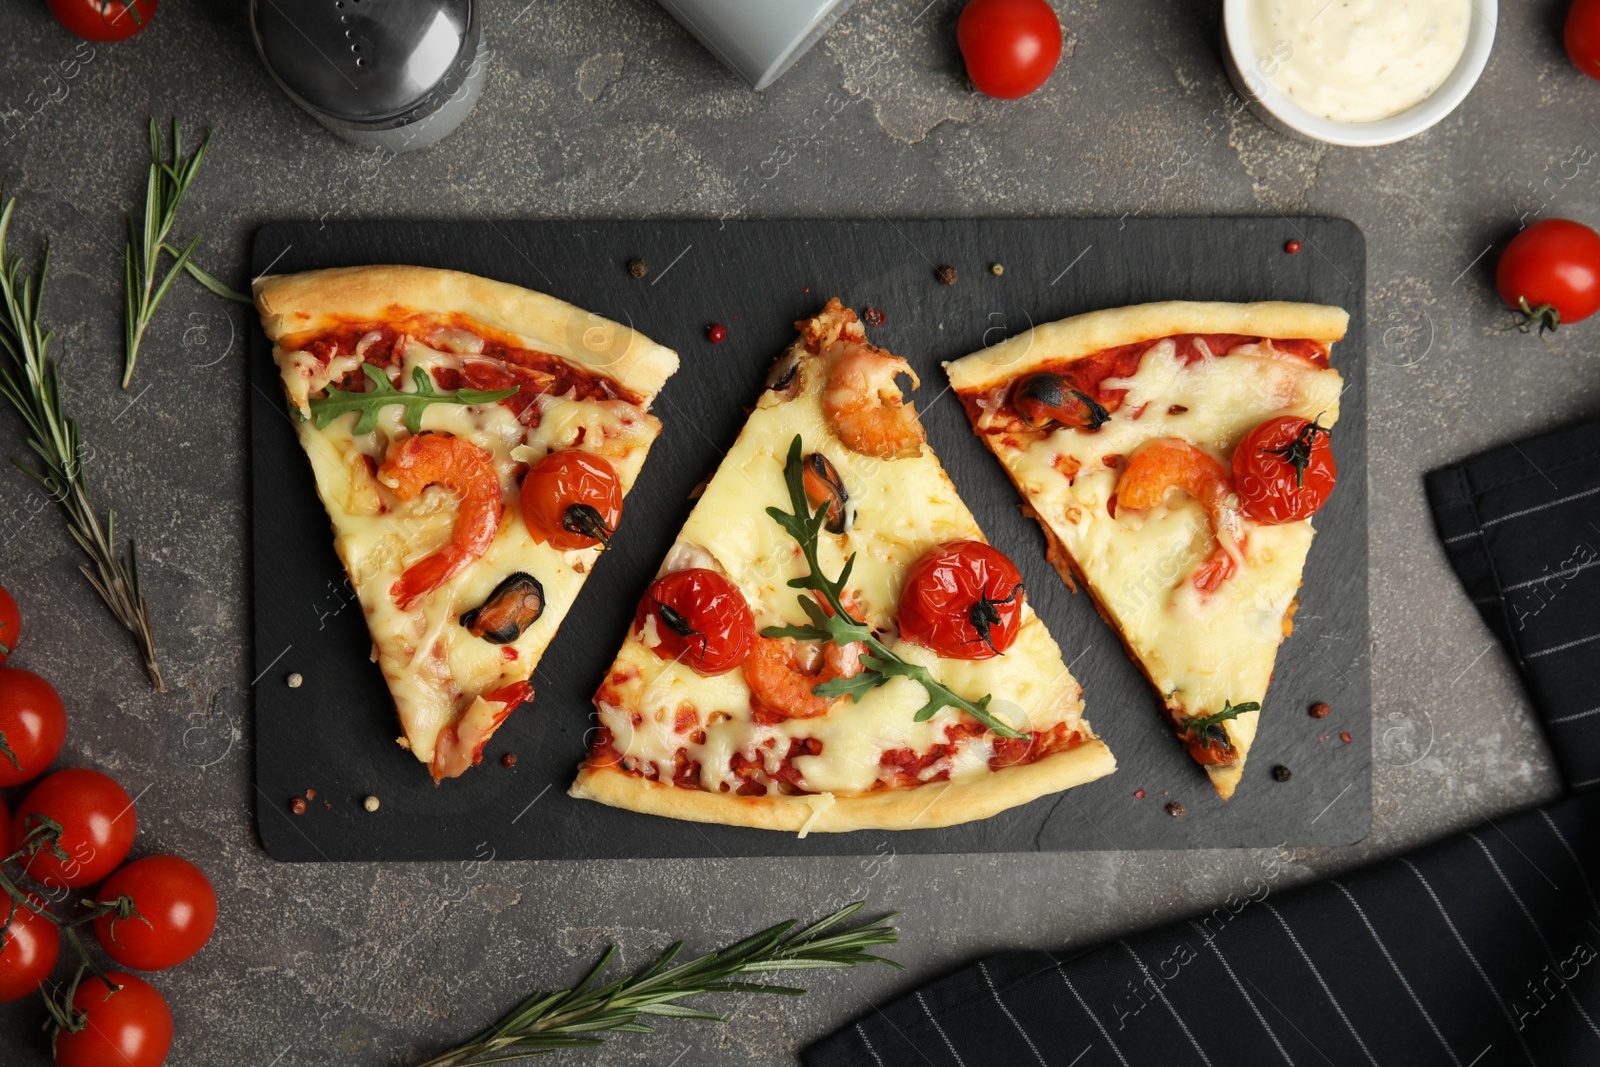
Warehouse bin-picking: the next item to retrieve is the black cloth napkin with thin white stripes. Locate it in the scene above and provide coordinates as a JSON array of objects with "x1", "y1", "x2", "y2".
[{"x1": 802, "y1": 422, "x2": 1600, "y2": 1067}]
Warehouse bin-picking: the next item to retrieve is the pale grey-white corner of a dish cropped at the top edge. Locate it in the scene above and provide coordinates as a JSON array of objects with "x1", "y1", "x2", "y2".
[{"x1": 658, "y1": 0, "x2": 854, "y2": 90}]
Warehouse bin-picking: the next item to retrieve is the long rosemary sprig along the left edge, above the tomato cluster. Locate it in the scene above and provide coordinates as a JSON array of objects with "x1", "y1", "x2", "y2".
[{"x1": 0, "y1": 197, "x2": 166, "y2": 693}]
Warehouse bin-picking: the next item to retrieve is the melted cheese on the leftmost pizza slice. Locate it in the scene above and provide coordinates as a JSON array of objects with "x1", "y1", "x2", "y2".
[{"x1": 277, "y1": 338, "x2": 661, "y2": 763}]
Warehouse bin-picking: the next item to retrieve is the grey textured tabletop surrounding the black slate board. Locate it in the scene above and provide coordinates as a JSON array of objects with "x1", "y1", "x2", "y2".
[{"x1": 0, "y1": 0, "x2": 1580, "y2": 1067}]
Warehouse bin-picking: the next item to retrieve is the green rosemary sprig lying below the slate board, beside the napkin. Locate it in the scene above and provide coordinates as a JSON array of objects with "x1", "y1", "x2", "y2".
[{"x1": 419, "y1": 901, "x2": 899, "y2": 1067}]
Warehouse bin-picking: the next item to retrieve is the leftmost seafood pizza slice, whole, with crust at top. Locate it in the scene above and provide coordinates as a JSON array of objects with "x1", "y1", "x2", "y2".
[{"x1": 254, "y1": 267, "x2": 678, "y2": 782}]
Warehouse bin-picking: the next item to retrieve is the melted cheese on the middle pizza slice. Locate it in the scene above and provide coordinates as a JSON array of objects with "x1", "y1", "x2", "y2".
[{"x1": 597, "y1": 347, "x2": 1088, "y2": 797}]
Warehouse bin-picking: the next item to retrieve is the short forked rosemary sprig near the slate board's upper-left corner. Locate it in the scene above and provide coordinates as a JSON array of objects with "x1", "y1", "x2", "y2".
[{"x1": 122, "y1": 118, "x2": 214, "y2": 389}]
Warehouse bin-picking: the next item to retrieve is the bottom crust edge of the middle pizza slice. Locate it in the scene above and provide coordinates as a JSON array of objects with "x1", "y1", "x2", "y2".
[{"x1": 566, "y1": 737, "x2": 1117, "y2": 833}]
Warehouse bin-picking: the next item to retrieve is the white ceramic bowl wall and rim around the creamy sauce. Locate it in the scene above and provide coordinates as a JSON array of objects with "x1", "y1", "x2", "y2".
[{"x1": 1222, "y1": 0, "x2": 1499, "y2": 147}]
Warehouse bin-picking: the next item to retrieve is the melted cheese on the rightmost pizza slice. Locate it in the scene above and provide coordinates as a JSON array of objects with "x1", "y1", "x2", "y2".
[{"x1": 987, "y1": 341, "x2": 1342, "y2": 733}]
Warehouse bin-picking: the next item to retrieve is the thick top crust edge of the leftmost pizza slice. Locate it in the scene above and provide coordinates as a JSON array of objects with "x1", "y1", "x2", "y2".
[{"x1": 253, "y1": 266, "x2": 678, "y2": 408}]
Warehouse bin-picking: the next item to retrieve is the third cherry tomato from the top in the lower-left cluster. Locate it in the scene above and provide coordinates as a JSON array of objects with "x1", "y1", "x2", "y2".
[{"x1": 11, "y1": 768, "x2": 138, "y2": 888}]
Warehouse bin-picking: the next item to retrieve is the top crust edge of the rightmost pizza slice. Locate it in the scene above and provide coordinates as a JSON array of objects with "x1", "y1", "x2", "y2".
[{"x1": 944, "y1": 301, "x2": 1350, "y2": 392}]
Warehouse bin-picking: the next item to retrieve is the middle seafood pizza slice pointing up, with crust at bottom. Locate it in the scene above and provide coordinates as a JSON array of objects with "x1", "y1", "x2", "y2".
[{"x1": 571, "y1": 299, "x2": 1115, "y2": 833}]
